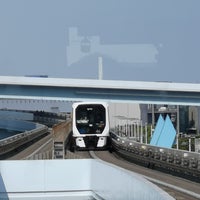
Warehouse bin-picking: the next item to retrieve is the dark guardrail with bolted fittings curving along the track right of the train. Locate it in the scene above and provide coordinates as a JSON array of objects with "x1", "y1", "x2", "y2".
[{"x1": 111, "y1": 133, "x2": 200, "y2": 182}]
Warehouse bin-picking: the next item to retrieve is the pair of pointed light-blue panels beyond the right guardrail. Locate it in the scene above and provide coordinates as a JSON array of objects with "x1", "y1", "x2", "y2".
[{"x1": 150, "y1": 115, "x2": 176, "y2": 148}]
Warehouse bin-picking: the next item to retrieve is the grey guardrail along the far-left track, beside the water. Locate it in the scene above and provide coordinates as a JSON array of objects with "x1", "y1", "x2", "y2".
[{"x1": 0, "y1": 125, "x2": 48, "y2": 155}]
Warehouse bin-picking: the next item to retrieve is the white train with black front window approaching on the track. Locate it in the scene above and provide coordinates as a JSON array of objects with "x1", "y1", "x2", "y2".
[{"x1": 71, "y1": 102, "x2": 110, "y2": 151}]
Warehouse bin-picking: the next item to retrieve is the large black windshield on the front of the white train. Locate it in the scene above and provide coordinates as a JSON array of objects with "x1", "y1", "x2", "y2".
[{"x1": 76, "y1": 104, "x2": 106, "y2": 134}]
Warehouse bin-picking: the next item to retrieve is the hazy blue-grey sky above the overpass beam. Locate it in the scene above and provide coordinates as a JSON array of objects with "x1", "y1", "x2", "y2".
[{"x1": 0, "y1": 0, "x2": 200, "y2": 82}]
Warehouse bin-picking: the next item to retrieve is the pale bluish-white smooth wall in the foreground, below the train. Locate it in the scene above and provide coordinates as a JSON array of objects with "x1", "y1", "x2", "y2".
[{"x1": 0, "y1": 159, "x2": 173, "y2": 200}]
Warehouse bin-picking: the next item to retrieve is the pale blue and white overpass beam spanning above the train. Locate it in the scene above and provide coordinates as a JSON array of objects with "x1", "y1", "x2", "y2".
[{"x1": 0, "y1": 76, "x2": 200, "y2": 105}]
